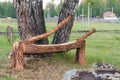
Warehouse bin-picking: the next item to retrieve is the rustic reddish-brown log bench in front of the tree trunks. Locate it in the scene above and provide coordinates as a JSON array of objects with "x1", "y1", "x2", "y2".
[{"x1": 11, "y1": 16, "x2": 96, "y2": 70}]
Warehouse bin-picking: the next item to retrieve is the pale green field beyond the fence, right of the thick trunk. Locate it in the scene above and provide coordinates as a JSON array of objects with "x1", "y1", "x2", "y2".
[{"x1": 46, "y1": 21, "x2": 120, "y2": 31}]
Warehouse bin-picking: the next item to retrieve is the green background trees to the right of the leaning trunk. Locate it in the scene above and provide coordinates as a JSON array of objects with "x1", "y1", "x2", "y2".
[{"x1": 77, "y1": 0, "x2": 120, "y2": 17}]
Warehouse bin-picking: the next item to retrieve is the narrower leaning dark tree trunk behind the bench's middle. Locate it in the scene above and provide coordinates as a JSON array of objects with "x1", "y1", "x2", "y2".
[{"x1": 52, "y1": 0, "x2": 79, "y2": 44}]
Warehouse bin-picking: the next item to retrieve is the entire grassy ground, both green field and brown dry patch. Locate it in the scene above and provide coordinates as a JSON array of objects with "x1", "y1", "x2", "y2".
[{"x1": 0, "y1": 22, "x2": 120, "y2": 80}]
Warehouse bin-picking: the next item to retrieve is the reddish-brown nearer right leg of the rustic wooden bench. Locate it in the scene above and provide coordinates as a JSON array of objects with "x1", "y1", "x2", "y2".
[{"x1": 79, "y1": 40, "x2": 86, "y2": 65}]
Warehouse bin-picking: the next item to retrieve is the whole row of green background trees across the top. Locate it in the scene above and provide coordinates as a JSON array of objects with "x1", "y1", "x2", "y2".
[{"x1": 0, "y1": 0, "x2": 120, "y2": 18}]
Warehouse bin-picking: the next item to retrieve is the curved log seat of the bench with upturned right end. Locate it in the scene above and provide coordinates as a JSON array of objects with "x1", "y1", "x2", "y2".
[{"x1": 22, "y1": 28, "x2": 96, "y2": 54}]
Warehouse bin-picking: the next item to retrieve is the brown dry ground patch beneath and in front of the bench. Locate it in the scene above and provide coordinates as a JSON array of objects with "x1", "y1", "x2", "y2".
[{"x1": 1, "y1": 57, "x2": 87, "y2": 80}]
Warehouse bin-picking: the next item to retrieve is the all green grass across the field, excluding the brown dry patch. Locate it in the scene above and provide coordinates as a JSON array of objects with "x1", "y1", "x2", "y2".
[{"x1": 0, "y1": 22, "x2": 120, "y2": 80}]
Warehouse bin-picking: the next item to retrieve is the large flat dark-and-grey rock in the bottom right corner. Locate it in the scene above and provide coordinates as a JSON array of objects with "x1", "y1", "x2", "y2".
[{"x1": 71, "y1": 70, "x2": 120, "y2": 80}]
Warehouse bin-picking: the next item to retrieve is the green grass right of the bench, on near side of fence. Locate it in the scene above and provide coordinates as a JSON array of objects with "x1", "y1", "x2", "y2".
[{"x1": 70, "y1": 32, "x2": 120, "y2": 68}]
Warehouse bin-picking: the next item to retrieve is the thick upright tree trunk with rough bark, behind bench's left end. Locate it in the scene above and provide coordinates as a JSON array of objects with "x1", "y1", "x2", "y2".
[{"x1": 14, "y1": 0, "x2": 48, "y2": 44}]
